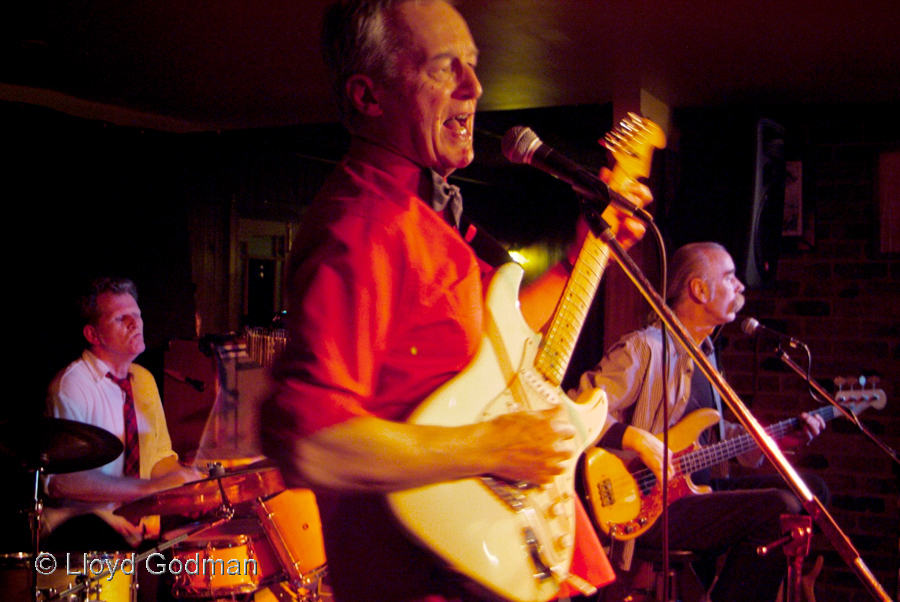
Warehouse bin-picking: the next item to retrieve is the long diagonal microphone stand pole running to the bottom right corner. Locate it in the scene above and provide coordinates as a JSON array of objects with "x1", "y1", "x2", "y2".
[{"x1": 585, "y1": 208, "x2": 891, "y2": 602}]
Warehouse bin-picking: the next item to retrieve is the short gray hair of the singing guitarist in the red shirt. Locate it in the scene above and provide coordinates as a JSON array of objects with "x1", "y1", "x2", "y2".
[{"x1": 322, "y1": 0, "x2": 439, "y2": 128}]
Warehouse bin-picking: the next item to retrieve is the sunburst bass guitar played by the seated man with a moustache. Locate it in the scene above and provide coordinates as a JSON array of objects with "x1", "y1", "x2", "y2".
[{"x1": 584, "y1": 389, "x2": 886, "y2": 541}]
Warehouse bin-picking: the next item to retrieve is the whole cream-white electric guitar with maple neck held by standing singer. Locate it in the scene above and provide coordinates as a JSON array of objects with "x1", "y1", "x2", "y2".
[{"x1": 387, "y1": 115, "x2": 665, "y2": 602}]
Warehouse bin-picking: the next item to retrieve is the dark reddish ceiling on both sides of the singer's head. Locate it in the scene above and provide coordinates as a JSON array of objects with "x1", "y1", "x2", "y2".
[{"x1": 0, "y1": 0, "x2": 900, "y2": 131}]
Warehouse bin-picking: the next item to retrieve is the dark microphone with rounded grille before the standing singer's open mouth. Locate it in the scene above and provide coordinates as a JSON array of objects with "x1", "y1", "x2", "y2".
[{"x1": 500, "y1": 125, "x2": 638, "y2": 215}]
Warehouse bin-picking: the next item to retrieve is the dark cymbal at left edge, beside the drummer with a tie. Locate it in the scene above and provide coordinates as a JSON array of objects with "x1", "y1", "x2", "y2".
[{"x1": 0, "y1": 416, "x2": 122, "y2": 474}]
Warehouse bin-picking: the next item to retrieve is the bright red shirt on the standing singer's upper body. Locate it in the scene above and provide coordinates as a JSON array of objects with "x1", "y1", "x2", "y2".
[{"x1": 276, "y1": 140, "x2": 483, "y2": 435}]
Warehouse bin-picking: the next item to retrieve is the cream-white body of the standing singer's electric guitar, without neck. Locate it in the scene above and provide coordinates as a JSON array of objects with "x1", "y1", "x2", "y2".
[{"x1": 387, "y1": 263, "x2": 606, "y2": 602}]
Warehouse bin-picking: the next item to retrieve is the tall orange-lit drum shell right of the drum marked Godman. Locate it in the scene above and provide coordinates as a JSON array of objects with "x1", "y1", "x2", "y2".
[{"x1": 256, "y1": 489, "x2": 325, "y2": 589}]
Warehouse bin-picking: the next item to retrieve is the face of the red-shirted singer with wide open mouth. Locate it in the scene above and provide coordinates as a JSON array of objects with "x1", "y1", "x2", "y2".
[{"x1": 380, "y1": 1, "x2": 481, "y2": 176}]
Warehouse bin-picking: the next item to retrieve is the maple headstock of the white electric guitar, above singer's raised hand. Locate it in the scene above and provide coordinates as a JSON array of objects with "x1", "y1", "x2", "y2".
[{"x1": 600, "y1": 113, "x2": 666, "y2": 181}]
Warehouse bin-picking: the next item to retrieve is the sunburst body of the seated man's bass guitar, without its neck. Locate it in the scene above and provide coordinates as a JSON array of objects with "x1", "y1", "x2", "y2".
[{"x1": 584, "y1": 409, "x2": 719, "y2": 540}]
